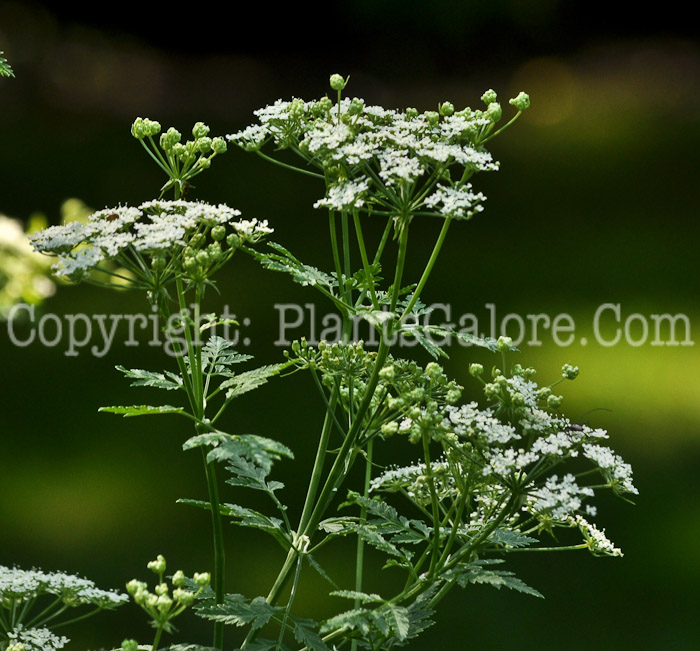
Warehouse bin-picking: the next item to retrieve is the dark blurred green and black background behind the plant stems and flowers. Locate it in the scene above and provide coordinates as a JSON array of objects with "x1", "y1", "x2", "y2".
[{"x1": 0, "y1": 0, "x2": 700, "y2": 651}]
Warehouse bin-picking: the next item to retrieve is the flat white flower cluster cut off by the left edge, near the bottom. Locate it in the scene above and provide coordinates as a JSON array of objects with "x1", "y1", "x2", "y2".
[{"x1": 0, "y1": 565, "x2": 129, "y2": 608}]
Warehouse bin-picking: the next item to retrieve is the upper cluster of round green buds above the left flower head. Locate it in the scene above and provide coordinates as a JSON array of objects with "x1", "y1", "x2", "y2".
[{"x1": 131, "y1": 118, "x2": 227, "y2": 199}]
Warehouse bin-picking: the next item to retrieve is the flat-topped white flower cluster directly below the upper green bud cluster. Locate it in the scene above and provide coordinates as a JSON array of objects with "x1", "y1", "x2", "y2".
[{"x1": 30, "y1": 200, "x2": 272, "y2": 279}]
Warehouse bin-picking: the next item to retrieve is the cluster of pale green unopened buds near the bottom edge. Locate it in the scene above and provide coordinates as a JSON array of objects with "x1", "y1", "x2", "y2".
[{"x1": 122, "y1": 554, "x2": 211, "y2": 651}]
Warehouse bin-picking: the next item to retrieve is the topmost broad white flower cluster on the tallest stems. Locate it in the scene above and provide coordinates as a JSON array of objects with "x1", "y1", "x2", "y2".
[{"x1": 227, "y1": 92, "x2": 498, "y2": 219}]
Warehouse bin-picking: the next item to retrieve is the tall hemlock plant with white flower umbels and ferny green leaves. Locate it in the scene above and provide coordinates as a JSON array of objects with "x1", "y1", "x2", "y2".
[{"x1": 0, "y1": 75, "x2": 637, "y2": 651}]
